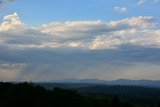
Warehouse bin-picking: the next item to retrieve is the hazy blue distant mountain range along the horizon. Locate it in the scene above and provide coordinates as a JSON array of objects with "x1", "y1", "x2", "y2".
[{"x1": 54, "y1": 79, "x2": 160, "y2": 88}]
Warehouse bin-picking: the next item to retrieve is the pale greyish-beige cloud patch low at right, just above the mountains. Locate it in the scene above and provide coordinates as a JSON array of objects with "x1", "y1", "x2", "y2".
[{"x1": 115, "y1": 63, "x2": 160, "y2": 80}]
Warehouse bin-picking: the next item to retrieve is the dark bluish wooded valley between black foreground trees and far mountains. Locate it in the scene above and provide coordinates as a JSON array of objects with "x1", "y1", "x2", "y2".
[{"x1": 38, "y1": 83, "x2": 160, "y2": 104}]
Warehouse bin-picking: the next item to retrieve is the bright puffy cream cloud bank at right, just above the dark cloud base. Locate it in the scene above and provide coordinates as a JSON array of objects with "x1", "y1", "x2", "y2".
[{"x1": 90, "y1": 29, "x2": 160, "y2": 49}]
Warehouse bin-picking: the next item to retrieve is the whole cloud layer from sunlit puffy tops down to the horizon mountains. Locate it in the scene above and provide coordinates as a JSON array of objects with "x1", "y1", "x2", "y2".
[{"x1": 0, "y1": 13, "x2": 160, "y2": 81}]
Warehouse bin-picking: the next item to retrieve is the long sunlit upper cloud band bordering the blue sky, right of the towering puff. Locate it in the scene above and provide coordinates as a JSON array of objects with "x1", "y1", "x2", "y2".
[{"x1": 37, "y1": 16, "x2": 156, "y2": 38}]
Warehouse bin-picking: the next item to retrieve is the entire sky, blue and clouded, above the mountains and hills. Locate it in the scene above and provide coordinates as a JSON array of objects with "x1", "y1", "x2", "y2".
[{"x1": 0, "y1": 0, "x2": 160, "y2": 82}]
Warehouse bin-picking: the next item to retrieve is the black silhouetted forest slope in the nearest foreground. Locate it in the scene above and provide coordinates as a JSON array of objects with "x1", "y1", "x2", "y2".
[{"x1": 0, "y1": 82, "x2": 160, "y2": 107}]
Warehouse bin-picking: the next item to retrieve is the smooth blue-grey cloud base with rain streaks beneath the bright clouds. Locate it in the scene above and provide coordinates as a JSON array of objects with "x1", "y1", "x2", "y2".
[{"x1": 0, "y1": 46, "x2": 160, "y2": 81}]
